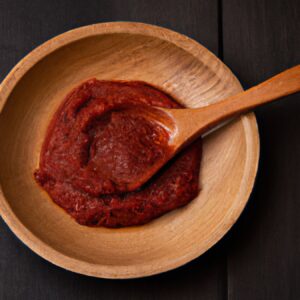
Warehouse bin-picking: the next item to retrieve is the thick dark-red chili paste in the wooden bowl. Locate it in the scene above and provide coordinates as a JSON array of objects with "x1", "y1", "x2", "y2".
[{"x1": 34, "y1": 79, "x2": 202, "y2": 227}]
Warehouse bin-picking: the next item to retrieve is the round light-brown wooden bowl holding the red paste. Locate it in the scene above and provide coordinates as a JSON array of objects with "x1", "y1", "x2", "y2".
[{"x1": 0, "y1": 22, "x2": 259, "y2": 278}]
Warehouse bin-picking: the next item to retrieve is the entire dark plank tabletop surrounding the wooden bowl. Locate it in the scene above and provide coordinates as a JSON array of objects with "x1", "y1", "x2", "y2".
[{"x1": 0, "y1": 0, "x2": 300, "y2": 300}]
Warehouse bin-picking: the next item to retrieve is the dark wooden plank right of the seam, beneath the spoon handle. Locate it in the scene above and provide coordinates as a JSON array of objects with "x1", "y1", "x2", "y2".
[{"x1": 223, "y1": 0, "x2": 300, "y2": 300}]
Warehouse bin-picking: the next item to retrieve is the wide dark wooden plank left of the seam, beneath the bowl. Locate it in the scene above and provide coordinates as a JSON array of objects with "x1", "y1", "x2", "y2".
[{"x1": 0, "y1": 0, "x2": 226, "y2": 299}]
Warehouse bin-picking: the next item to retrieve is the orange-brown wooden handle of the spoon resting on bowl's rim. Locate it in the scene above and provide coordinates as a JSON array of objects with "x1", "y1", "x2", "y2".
[{"x1": 168, "y1": 65, "x2": 300, "y2": 150}]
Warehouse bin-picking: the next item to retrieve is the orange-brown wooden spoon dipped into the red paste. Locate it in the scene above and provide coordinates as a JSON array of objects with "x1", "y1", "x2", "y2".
[{"x1": 134, "y1": 65, "x2": 300, "y2": 189}]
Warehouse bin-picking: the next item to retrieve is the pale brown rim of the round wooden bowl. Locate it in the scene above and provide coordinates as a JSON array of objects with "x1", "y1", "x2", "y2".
[{"x1": 0, "y1": 22, "x2": 260, "y2": 279}]
